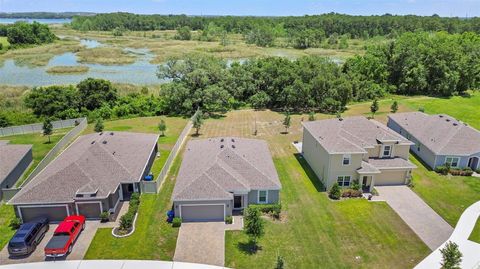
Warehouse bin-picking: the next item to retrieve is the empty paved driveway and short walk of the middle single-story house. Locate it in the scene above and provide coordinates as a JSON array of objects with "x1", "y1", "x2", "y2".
[{"x1": 173, "y1": 216, "x2": 243, "y2": 266}]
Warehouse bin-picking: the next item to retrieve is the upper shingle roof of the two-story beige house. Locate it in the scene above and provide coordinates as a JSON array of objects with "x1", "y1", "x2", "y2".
[{"x1": 303, "y1": 116, "x2": 412, "y2": 154}]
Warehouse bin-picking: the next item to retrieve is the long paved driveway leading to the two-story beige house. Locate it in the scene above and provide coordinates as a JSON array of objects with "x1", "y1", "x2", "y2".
[{"x1": 375, "y1": 186, "x2": 453, "y2": 250}]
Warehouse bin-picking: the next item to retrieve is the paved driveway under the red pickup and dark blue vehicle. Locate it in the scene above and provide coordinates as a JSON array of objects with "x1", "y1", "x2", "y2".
[{"x1": 0, "y1": 221, "x2": 99, "y2": 264}]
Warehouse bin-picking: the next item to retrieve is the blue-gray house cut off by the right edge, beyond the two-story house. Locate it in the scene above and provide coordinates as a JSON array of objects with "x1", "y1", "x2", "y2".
[{"x1": 388, "y1": 112, "x2": 480, "y2": 170}]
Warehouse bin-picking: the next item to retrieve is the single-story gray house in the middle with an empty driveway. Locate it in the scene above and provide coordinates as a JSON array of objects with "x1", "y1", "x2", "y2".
[{"x1": 173, "y1": 137, "x2": 281, "y2": 221}]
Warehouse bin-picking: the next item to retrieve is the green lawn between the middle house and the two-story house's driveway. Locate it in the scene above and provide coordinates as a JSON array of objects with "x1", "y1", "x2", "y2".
[{"x1": 225, "y1": 155, "x2": 430, "y2": 268}]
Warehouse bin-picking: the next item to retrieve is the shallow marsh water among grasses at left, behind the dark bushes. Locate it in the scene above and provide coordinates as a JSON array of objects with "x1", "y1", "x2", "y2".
[{"x1": 0, "y1": 39, "x2": 164, "y2": 86}]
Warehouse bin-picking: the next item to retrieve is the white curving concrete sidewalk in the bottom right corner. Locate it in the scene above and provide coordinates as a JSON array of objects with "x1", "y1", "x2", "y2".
[{"x1": 415, "y1": 201, "x2": 480, "y2": 269}]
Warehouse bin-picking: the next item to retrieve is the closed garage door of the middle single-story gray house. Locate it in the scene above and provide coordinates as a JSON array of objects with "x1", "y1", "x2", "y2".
[{"x1": 181, "y1": 204, "x2": 225, "y2": 221}]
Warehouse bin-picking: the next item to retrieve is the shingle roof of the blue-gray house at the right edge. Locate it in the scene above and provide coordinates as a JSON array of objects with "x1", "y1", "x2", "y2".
[{"x1": 389, "y1": 112, "x2": 480, "y2": 156}]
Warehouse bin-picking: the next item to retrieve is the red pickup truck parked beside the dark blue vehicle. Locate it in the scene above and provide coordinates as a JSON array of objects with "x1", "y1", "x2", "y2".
[{"x1": 45, "y1": 216, "x2": 85, "y2": 258}]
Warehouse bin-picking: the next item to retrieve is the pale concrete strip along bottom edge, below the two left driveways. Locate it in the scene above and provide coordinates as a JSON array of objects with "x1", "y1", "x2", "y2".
[{"x1": 0, "y1": 260, "x2": 228, "y2": 269}]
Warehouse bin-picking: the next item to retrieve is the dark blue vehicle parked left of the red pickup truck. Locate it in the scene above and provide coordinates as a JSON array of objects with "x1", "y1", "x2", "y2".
[{"x1": 8, "y1": 218, "x2": 48, "y2": 257}]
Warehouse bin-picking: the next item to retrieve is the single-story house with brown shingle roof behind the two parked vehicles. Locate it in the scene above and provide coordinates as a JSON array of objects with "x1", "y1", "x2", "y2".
[{"x1": 9, "y1": 132, "x2": 158, "y2": 222}]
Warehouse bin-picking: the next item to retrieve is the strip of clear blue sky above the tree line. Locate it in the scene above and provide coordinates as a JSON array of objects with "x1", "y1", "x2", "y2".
[{"x1": 0, "y1": 0, "x2": 480, "y2": 17}]
